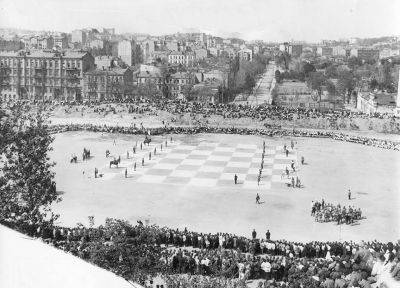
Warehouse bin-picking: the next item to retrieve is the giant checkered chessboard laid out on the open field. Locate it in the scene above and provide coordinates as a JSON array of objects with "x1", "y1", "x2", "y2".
[{"x1": 104, "y1": 141, "x2": 297, "y2": 189}]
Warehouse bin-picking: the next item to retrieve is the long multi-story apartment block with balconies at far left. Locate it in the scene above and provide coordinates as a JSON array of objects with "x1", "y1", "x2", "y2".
[{"x1": 0, "y1": 50, "x2": 94, "y2": 102}]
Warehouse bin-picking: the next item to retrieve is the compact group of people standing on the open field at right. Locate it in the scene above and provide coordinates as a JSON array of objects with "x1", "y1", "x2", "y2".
[{"x1": 311, "y1": 200, "x2": 362, "y2": 225}]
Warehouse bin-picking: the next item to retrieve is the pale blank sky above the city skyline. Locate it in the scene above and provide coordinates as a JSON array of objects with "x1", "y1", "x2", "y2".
[{"x1": 0, "y1": 0, "x2": 400, "y2": 42}]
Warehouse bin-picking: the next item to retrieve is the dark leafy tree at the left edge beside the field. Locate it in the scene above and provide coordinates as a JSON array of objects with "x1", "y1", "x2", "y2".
[{"x1": 0, "y1": 105, "x2": 60, "y2": 223}]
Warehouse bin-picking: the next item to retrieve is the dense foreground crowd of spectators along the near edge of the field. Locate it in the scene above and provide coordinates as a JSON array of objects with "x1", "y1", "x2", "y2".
[{"x1": 1, "y1": 215, "x2": 400, "y2": 288}]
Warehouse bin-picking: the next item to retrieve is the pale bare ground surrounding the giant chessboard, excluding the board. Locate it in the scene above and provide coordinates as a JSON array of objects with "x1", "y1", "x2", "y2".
[{"x1": 51, "y1": 132, "x2": 400, "y2": 241}]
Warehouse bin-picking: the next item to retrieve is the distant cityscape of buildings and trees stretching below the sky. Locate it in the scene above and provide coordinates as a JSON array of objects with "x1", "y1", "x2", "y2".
[{"x1": 0, "y1": 28, "x2": 400, "y2": 114}]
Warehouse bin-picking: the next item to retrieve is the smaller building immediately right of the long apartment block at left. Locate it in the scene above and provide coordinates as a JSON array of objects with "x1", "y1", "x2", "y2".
[{"x1": 83, "y1": 67, "x2": 133, "y2": 102}]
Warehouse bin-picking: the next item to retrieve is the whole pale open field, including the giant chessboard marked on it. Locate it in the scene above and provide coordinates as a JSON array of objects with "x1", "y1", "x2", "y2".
[{"x1": 52, "y1": 132, "x2": 400, "y2": 241}]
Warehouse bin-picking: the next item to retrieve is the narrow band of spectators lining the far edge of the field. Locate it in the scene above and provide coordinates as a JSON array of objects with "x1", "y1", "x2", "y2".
[{"x1": 50, "y1": 124, "x2": 400, "y2": 150}]
